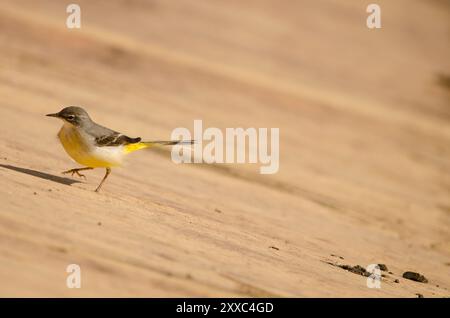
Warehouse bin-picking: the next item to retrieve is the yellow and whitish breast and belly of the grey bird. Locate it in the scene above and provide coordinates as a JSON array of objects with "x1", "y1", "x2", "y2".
[{"x1": 58, "y1": 124, "x2": 125, "y2": 168}]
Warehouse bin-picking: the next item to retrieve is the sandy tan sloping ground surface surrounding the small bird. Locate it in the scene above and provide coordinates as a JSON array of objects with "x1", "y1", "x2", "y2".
[{"x1": 0, "y1": 0, "x2": 450, "y2": 297}]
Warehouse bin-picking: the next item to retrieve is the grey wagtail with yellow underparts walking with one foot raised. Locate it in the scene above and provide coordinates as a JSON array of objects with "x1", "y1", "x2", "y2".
[{"x1": 47, "y1": 106, "x2": 194, "y2": 192}]
